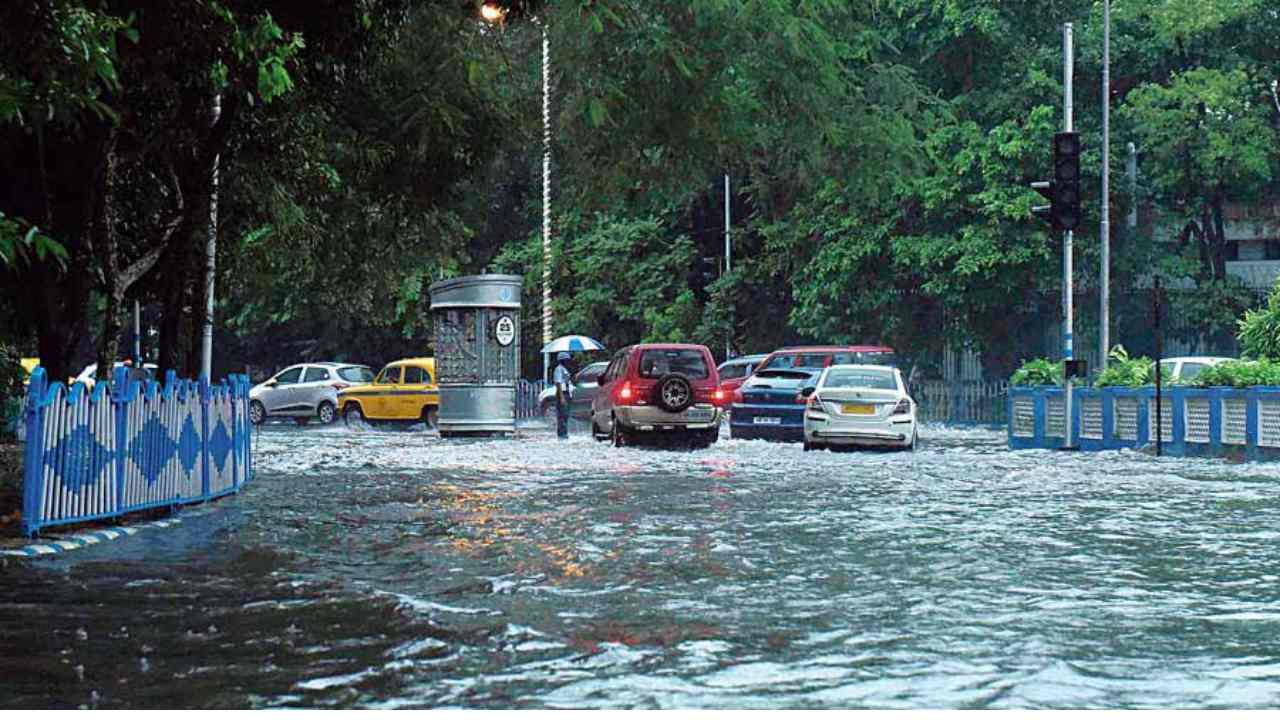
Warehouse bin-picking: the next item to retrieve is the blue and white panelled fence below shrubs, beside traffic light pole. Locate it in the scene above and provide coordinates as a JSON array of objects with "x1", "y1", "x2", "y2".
[{"x1": 1009, "y1": 386, "x2": 1280, "y2": 460}]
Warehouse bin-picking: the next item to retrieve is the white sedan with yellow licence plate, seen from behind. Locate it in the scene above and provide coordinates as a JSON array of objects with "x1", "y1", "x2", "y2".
[{"x1": 801, "y1": 365, "x2": 916, "y2": 450}]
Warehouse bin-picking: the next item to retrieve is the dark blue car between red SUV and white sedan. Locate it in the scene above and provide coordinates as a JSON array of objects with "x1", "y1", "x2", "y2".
[{"x1": 728, "y1": 368, "x2": 822, "y2": 442}]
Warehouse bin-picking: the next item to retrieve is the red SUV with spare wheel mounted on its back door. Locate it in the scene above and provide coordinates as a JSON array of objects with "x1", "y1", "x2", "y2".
[{"x1": 591, "y1": 345, "x2": 726, "y2": 447}]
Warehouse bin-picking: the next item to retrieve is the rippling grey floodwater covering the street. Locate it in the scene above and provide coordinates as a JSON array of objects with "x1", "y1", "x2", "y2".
[{"x1": 0, "y1": 427, "x2": 1280, "y2": 708}]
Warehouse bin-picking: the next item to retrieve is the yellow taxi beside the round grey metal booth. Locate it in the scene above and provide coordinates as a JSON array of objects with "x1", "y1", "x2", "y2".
[{"x1": 338, "y1": 357, "x2": 440, "y2": 428}]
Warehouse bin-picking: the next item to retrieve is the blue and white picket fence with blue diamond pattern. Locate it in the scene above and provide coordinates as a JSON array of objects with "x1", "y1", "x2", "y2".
[{"x1": 22, "y1": 368, "x2": 253, "y2": 536}]
